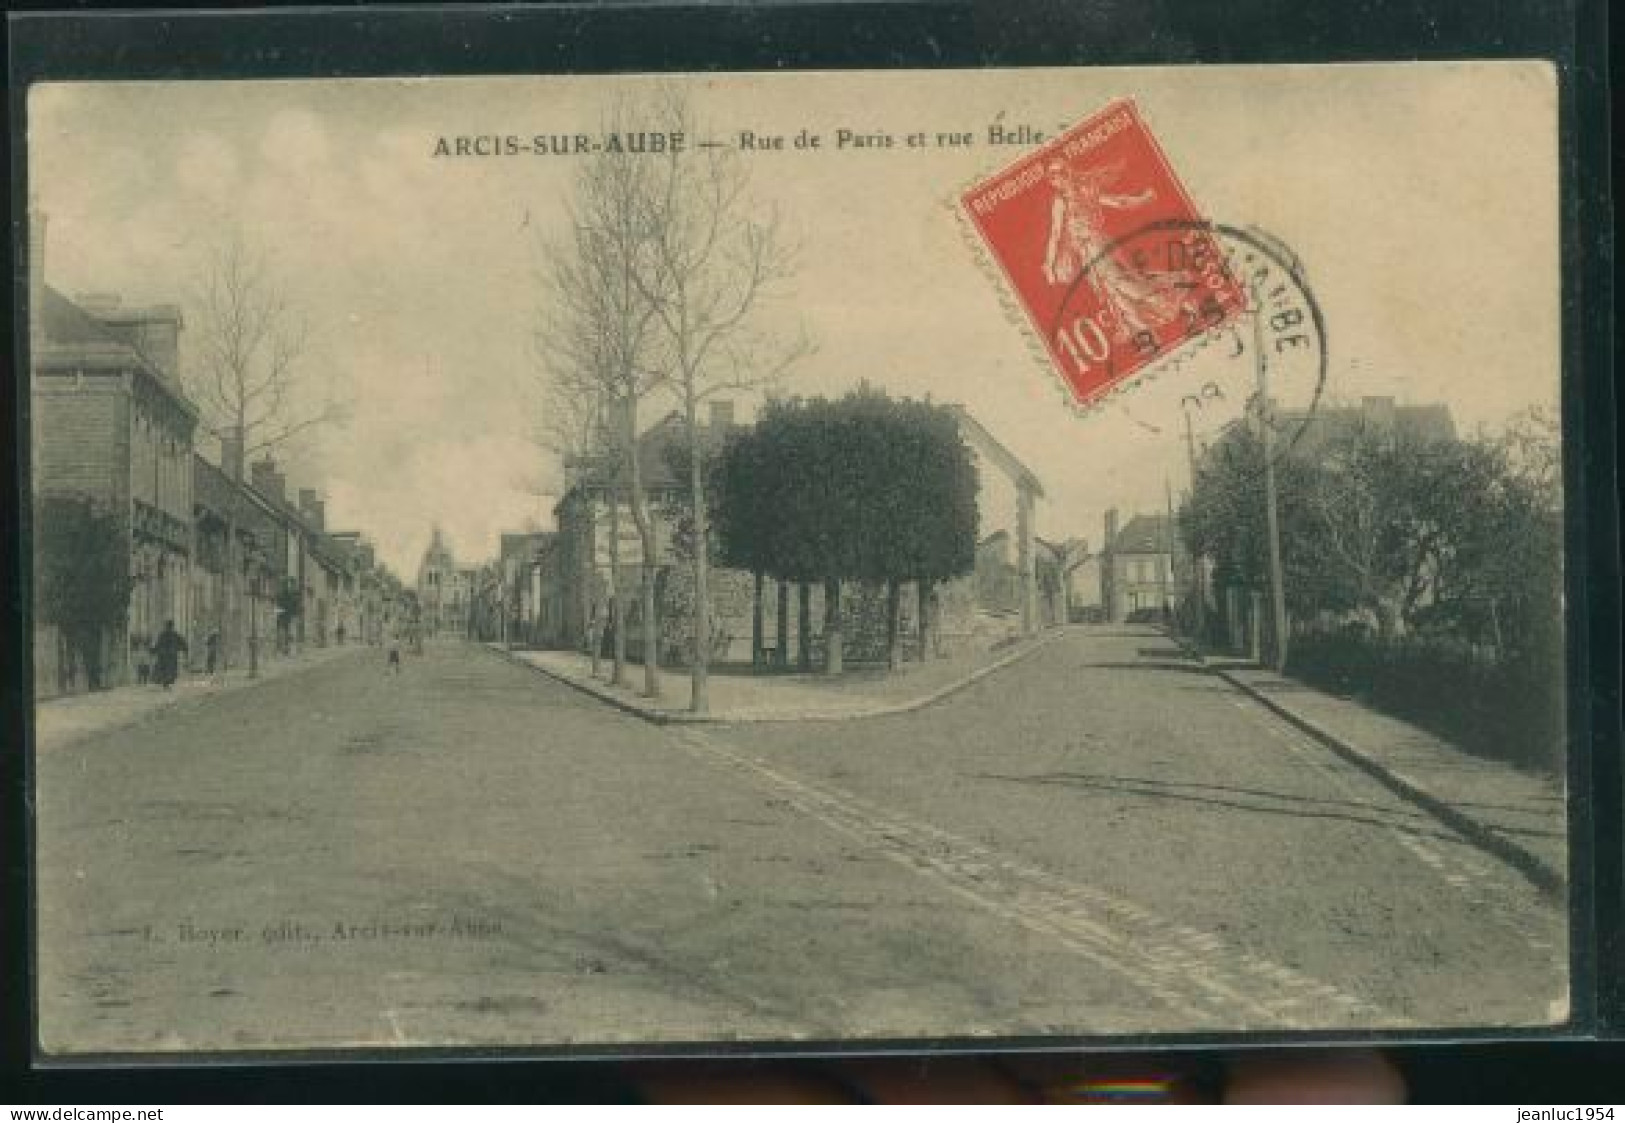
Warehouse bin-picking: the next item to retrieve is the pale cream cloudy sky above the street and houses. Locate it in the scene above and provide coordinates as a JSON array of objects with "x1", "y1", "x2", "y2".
[{"x1": 28, "y1": 63, "x2": 1560, "y2": 579}]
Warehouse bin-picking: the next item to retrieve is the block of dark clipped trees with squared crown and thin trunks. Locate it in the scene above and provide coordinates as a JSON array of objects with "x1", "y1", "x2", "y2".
[{"x1": 715, "y1": 387, "x2": 977, "y2": 673}]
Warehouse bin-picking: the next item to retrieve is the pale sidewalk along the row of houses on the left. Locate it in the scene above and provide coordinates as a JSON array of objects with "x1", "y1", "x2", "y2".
[{"x1": 34, "y1": 644, "x2": 364, "y2": 752}]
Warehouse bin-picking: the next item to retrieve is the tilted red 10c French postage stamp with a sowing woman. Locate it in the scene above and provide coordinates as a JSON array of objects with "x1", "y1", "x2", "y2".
[{"x1": 960, "y1": 101, "x2": 1246, "y2": 405}]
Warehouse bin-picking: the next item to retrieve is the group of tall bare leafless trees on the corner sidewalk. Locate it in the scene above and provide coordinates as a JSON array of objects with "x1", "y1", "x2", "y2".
[{"x1": 535, "y1": 91, "x2": 811, "y2": 713}]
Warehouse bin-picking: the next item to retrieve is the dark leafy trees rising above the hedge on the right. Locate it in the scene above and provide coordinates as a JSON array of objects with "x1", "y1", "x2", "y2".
[{"x1": 1181, "y1": 413, "x2": 1562, "y2": 653}]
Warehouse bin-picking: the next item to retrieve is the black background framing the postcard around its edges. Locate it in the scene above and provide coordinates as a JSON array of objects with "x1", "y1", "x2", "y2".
[{"x1": 0, "y1": 0, "x2": 1625, "y2": 1107}]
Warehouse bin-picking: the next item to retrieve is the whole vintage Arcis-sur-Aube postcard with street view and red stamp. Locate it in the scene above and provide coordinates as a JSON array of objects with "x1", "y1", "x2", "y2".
[{"x1": 23, "y1": 62, "x2": 1571, "y2": 1060}]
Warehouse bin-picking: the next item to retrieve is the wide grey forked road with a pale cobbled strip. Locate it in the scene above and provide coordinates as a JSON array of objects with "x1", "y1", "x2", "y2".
[{"x1": 36, "y1": 629, "x2": 1567, "y2": 1053}]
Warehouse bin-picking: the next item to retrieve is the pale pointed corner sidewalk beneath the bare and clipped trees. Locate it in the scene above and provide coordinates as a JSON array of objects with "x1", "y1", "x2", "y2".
[{"x1": 488, "y1": 629, "x2": 1064, "y2": 723}]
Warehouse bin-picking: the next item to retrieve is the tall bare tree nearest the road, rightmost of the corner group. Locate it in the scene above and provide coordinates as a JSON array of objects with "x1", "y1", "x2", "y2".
[{"x1": 634, "y1": 91, "x2": 811, "y2": 713}]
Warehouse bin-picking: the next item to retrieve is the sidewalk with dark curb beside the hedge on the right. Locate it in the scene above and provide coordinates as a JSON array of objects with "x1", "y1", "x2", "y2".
[{"x1": 1203, "y1": 657, "x2": 1568, "y2": 892}]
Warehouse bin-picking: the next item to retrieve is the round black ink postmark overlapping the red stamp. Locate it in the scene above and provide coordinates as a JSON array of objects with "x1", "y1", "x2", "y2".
[{"x1": 1050, "y1": 219, "x2": 1328, "y2": 457}]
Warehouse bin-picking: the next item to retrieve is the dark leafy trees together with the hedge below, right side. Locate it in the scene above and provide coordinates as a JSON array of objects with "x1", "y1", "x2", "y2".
[{"x1": 1181, "y1": 413, "x2": 1563, "y2": 765}]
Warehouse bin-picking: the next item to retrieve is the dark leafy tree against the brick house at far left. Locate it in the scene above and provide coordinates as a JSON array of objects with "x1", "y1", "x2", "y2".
[{"x1": 34, "y1": 494, "x2": 132, "y2": 691}]
